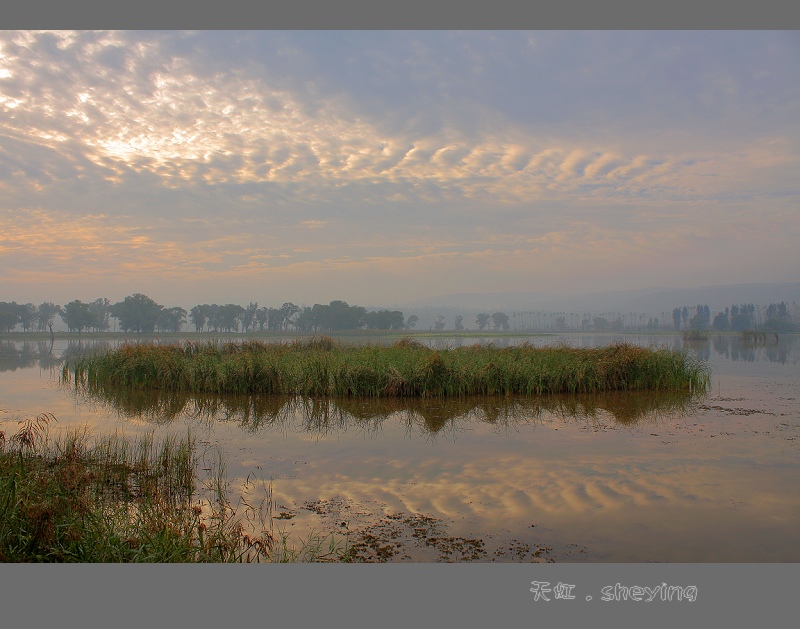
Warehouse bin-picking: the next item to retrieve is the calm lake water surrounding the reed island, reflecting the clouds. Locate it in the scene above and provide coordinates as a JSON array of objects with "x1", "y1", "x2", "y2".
[{"x1": 0, "y1": 335, "x2": 800, "y2": 562}]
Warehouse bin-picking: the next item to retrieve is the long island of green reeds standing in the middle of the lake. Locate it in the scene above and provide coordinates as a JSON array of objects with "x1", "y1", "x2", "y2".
[{"x1": 62, "y1": 337, "x2": 710, "y2": 397}]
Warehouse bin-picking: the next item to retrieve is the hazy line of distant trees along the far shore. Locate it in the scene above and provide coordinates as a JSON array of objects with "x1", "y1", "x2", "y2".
[{"x1": 0, "y1": 293, "x2": 800, "y2": 334}]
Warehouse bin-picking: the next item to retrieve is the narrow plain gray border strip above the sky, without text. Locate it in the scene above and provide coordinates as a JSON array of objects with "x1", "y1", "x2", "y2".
[{"x1": 2, "y1": 0, "x2": 800, "y2": 30}]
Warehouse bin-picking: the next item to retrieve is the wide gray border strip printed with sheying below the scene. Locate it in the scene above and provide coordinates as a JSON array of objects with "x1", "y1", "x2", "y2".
[{"x1": 6, "y1": 564, "x2": 800, "y2": 628}]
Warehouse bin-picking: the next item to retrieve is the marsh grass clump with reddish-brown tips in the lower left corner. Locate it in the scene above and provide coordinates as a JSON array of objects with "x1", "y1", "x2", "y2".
[{"x1": 0, "y1": 414, "x2": 344, "y2": 563}]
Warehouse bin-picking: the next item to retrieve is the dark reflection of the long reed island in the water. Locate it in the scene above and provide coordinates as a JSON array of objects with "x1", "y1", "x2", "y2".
[{"x1": 70, "y1": 376, "x2": 708, "y2": 435}]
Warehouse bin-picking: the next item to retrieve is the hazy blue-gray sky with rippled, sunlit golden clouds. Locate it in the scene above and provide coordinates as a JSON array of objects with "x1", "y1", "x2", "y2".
[{"x1": 0, "y1": 31, "x2": 800, "y2": 309}]
